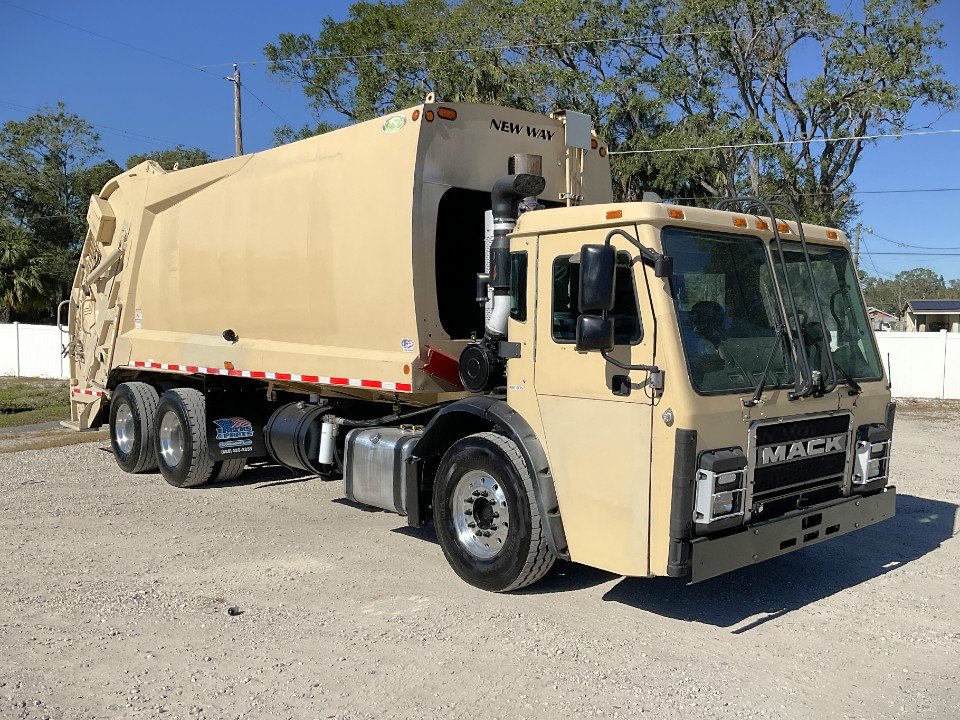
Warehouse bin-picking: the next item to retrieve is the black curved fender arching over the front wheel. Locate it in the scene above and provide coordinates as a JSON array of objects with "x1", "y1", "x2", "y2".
[{"x1": 407, "y1": 396, "x2": 570, "y2": 560}]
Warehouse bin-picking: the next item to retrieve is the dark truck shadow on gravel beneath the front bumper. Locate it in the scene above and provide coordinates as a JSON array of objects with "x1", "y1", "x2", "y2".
[{"x1": 603, "y1": 495, "x2": 958, "y2": 633}]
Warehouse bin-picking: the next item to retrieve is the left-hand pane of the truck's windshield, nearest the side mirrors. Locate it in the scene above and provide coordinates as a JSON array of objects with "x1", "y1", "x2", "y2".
[{"x1": 662, "y1": 228, "x2": 802, "y2": 394}]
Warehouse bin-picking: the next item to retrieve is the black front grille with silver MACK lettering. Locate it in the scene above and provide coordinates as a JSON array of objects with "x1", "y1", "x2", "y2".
[{"x1": 748, "y1": 414, "x2": 852, "y2": 520}]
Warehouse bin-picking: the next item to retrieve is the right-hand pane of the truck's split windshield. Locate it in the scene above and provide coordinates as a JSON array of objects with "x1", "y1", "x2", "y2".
[{"x1": 773, "y1": 242, "x2": 881, "y2": 383}]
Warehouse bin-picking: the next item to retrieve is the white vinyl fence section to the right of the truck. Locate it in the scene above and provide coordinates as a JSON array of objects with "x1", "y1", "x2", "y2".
[{"x1": 877, "y1": 330, "x2": 960, "y2": 400}]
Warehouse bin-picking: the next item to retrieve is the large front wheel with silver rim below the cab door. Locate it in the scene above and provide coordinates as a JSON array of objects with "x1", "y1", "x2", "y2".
[{"x1": 433, "y1": 432, "x2": 556, "y2": 592}]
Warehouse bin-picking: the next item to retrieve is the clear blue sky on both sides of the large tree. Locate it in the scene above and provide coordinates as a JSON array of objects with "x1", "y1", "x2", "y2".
[{"x1": 0, "y1": 0, "x2": 960, "y2": 280}]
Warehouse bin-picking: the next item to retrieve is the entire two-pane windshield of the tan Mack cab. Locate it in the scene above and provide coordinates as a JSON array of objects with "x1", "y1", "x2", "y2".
[{"x1": 662, "y1": 228, "x2": 880, "y2": 394}]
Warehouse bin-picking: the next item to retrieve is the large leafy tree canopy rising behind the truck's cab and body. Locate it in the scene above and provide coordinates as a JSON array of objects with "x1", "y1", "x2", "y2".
[{"x1": 264, "y1": 0, "x2": 957, "y2": 226}]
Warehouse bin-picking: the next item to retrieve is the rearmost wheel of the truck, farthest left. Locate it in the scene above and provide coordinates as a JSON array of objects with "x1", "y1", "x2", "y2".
[{"x1": 110, "y1": 382, "x2": 160, "y2": 473}]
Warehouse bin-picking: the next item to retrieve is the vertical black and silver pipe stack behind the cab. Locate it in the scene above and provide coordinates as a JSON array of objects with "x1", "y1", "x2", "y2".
[{"x1": 460, "y1": 155, "x2": 547, "y2": 392}]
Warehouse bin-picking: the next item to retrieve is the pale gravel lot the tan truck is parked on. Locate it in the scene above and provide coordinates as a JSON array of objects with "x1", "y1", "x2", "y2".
[{"x1": 0, "y1": 405, "x2": 960, "y2": 720}]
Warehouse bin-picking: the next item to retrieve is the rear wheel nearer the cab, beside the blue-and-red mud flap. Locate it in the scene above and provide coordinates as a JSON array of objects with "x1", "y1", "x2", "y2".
[{"x1": 154, "y1": 388, "x2": 216, "y2": 487}]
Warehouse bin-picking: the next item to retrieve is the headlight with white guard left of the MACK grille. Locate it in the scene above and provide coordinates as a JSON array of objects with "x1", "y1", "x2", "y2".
[{"x1": 694, "y1": 449, "x2": 747, "y2": 531}]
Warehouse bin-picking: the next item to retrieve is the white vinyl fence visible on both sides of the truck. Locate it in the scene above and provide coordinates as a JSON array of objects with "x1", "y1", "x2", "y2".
[{"x1": 0, "y1": 323, "x2": 960, "y2": 399}]
